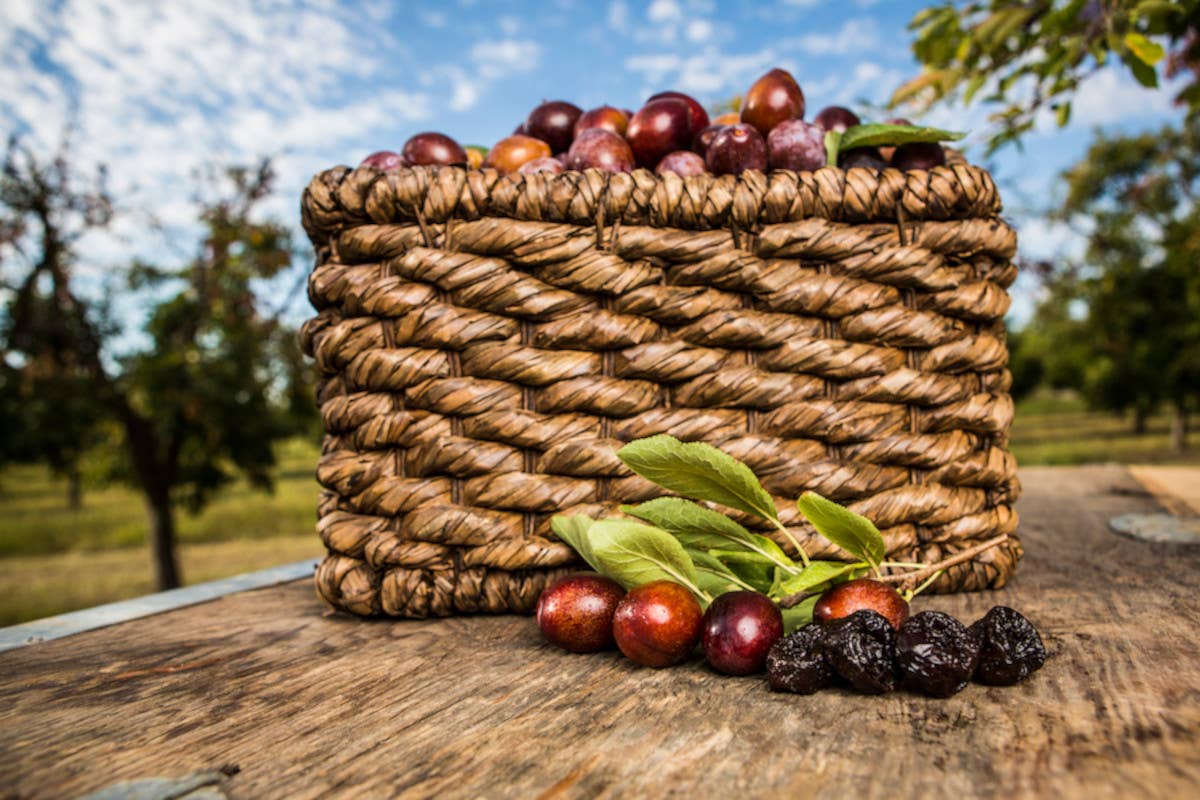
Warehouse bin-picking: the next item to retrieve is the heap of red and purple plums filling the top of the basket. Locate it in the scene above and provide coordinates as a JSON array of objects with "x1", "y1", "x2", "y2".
[{"x1": 361, "y1": 68, "x2": 946, "y2": 175}]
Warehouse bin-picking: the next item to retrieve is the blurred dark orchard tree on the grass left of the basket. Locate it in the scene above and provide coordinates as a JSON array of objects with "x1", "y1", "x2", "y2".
[{"x1": 0, "y1": 143, "x2": 309, "y2": 589}]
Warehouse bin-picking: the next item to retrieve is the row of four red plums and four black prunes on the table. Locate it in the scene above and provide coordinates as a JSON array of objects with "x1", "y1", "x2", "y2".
[{"x1": 536, "y1": 573, "x2": 1046, "y2": 697}]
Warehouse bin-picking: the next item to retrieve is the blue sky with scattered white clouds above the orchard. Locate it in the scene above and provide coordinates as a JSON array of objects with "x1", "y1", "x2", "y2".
[{"x1": 0, "y1": 0, "x2": 1182, "y2": 331}]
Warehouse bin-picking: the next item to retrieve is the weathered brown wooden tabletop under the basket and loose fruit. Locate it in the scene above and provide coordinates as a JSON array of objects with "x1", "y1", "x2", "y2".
[{"x1": 0, "y1": 467, "x2": 1200, "y2": 800}]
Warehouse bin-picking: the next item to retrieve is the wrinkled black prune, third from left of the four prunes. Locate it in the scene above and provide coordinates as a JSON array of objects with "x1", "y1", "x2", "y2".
[{"x1": 896, "y1": 612, "x2": 979, "y2": 697}]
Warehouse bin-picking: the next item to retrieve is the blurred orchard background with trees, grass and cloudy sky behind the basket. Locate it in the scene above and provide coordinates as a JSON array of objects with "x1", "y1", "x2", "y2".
[{"x1": 0, "y1": 0, "x2": 1200, "y2": 625}]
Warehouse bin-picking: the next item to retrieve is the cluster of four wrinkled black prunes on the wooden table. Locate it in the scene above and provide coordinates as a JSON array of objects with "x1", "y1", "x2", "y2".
[{"x1": 767, "y1": 606, "x2": 1046, "y2": 697}]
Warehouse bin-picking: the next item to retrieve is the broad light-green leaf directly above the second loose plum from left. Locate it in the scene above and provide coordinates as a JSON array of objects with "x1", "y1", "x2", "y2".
[{"x1": 587, "y1": 519, "x2": 696, "y2": 590}]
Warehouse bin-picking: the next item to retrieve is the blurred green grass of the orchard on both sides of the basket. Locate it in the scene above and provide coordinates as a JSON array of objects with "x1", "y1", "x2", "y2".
[{"x1": 0, "y1": 395, "x2": 1200, "y2": 626}]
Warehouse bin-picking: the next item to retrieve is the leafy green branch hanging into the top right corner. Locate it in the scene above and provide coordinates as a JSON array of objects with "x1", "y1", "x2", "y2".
[{"x1": 892, "y1": 0, "x2": 1200, "y2": 152}]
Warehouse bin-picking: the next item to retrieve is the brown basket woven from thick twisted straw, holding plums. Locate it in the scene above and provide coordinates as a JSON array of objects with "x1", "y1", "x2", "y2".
[{"x1": 302, "y1": 163, "x2": 1021, "y2": 616}]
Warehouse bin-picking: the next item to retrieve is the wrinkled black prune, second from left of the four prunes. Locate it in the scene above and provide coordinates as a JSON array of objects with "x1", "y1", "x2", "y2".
[{"x1": 824, "y1": 610, "x2": 896, "y2": 694}]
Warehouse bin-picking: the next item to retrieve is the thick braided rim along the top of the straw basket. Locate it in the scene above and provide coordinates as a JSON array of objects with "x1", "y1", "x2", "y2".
[{"x1": 301, "y1": 163, "x2": 1002, "y2": 247}]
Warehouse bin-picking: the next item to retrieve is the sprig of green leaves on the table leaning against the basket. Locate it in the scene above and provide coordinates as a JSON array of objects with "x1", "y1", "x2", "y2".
[{"x1": 551, "y1": 435, "x2": 974, "y2": 630}]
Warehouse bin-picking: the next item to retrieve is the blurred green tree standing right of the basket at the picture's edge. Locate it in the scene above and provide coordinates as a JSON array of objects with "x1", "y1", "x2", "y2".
[{"x1": 1057, "y1": 118, "x2": 1200, "y2": 450}]
